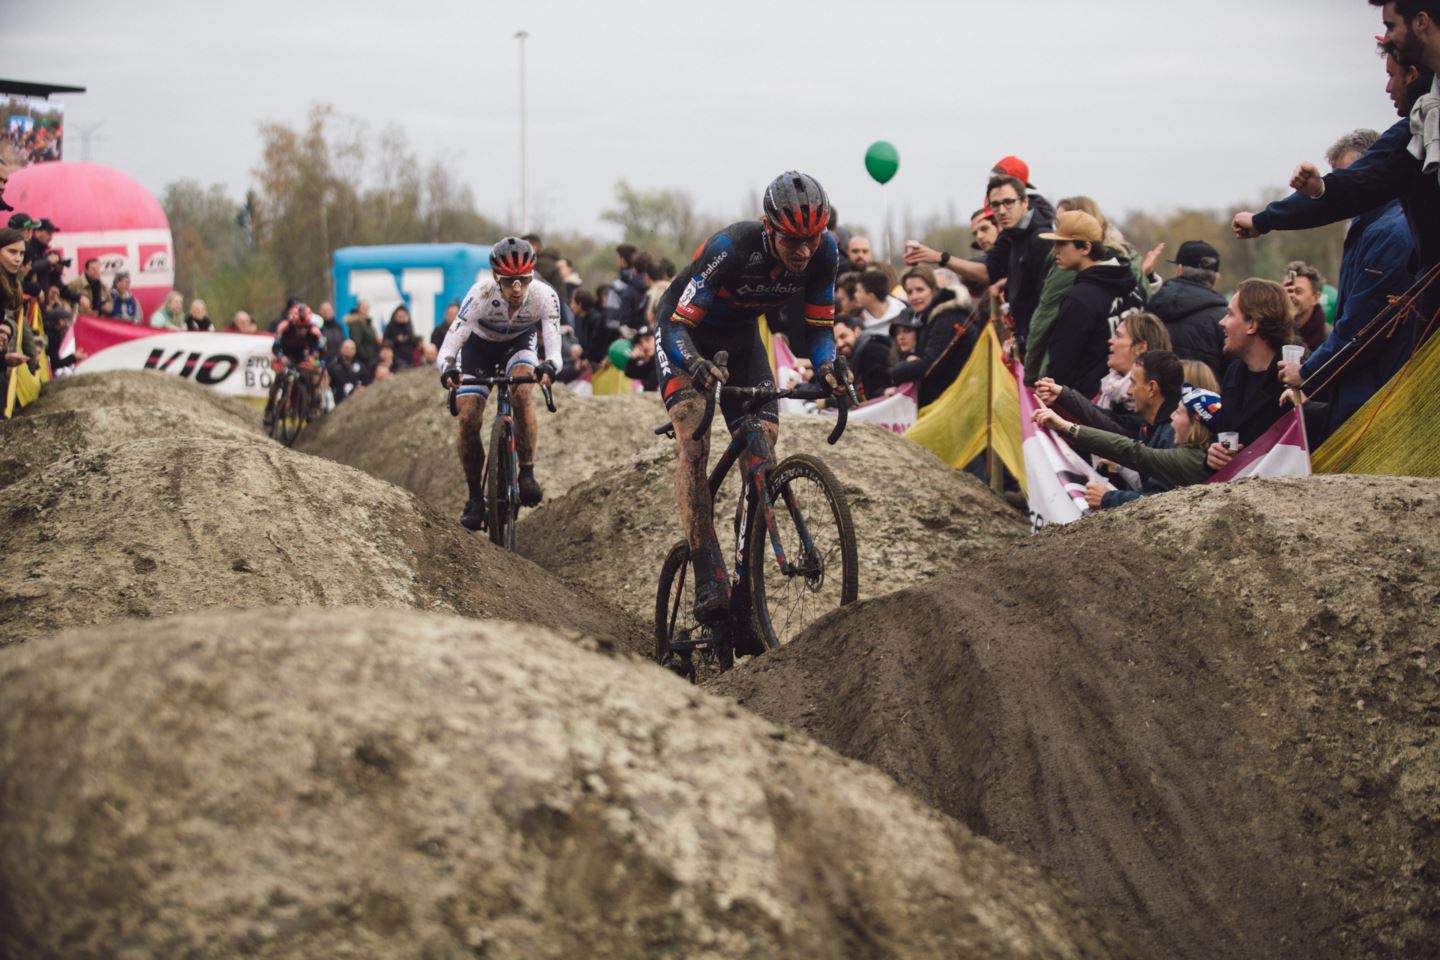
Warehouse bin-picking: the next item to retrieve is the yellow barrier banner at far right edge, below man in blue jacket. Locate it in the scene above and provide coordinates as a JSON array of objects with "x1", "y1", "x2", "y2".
[{"x1": 1310, "y1": 326, "x2": 1440, "y2": 476}]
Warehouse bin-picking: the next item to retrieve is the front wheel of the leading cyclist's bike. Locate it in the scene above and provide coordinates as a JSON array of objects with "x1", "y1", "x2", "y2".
[{"x1": 746, "y1": 453, "x2": 860, "y2": 649}]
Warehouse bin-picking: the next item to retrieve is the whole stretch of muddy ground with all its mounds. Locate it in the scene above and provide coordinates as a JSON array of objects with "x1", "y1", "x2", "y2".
[{"x1": 0, "y1": 373, "x2": 1440, "y2": 960}]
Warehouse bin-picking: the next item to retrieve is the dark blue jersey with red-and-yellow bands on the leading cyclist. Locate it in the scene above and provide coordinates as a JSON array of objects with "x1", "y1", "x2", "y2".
[{"x1": 655, "y1": 220, "x2": 840, "y2": 379}]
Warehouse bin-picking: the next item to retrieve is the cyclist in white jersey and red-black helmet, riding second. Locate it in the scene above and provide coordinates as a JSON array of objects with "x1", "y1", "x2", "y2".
[{"x1": 436, "y1": 236, "x2": 560, "y2": 530}]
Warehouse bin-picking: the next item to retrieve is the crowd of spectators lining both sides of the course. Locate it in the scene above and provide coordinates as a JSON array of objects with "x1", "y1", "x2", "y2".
[{"x1": 0, "y1": 0, "x2": 1440, "y2": 507}]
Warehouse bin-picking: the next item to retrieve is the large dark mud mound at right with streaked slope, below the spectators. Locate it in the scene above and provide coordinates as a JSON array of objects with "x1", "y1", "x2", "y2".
[{"x1": 719, "y1": 476, "x2": 1440, "y2": 957}]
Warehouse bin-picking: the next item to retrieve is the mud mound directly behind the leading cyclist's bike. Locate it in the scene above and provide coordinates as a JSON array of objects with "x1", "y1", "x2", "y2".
[{"x1": 516, "y1": 416, "x2": 1028, "y2": 620}]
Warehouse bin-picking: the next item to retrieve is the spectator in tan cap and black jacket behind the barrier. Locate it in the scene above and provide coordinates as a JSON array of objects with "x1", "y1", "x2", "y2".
[{"x1": 1038, "y1": 210, "x2": 1145, "y2": 397}]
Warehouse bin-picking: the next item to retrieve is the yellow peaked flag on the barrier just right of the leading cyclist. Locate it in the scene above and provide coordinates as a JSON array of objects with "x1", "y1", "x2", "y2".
[{"x1": 904, "y1": 324, "x2": 1025, "y2": 486}]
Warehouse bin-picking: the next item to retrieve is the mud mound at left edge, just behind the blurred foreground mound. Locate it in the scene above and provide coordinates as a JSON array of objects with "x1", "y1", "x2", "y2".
[{"x1": 0, "y1": 397, "x2": 644, "y2": 648}]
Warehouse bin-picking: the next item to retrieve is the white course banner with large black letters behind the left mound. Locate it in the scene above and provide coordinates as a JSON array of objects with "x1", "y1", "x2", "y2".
[{"x1": 75, "y1": 332, "x2": 274, "y2": 399}]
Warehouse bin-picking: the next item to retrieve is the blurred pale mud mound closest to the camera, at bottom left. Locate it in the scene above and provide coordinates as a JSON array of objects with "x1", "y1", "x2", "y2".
[{"x1": 0, "y1": 610, "x2": 1132, "y2": 960}]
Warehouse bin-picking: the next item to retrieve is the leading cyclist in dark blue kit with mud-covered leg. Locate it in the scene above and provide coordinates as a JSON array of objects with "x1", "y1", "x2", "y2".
[{"x1": 655, "y1": 171, "x2": 847, "y2": 623}]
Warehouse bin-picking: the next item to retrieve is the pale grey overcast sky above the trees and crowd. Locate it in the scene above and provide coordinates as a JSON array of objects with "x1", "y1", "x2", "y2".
[{"x1": 0, "y1": 0, "x2": 1395, "y2": 243}]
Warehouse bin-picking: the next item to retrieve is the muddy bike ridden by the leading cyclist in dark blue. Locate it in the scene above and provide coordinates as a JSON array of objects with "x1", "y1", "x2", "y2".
[{"x1": 655, "y1": 353, "x2": 860, "y2": 682}]
